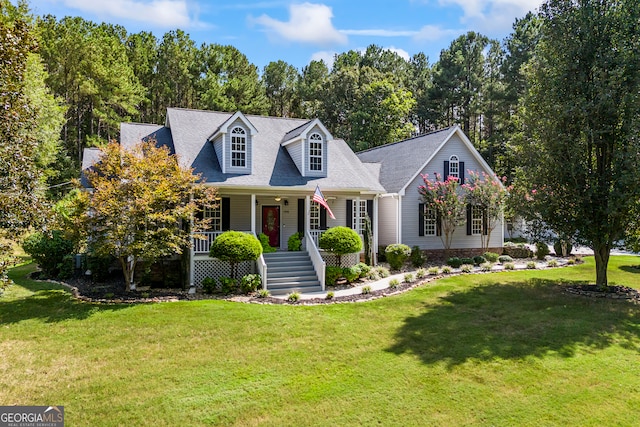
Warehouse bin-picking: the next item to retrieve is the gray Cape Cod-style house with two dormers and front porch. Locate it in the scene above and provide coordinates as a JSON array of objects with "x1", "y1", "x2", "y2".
[{"x1": 83, "y1": 108, "x2": 502, "y2": 293}]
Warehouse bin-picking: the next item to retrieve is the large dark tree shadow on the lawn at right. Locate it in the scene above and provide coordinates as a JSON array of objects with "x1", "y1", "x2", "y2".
[{"x1": 388, "y1": 279, "x2": 640, "y2": 367}]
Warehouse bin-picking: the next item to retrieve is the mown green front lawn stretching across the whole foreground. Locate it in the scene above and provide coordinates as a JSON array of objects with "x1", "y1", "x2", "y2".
[{"x1": 0, "y1": 257, "x2": 640, "y2": 426}]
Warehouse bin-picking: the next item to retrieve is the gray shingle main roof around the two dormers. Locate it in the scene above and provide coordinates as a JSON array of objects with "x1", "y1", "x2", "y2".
[{"x1": 121, "y1": 108, "x2": 384, "y2": 192}]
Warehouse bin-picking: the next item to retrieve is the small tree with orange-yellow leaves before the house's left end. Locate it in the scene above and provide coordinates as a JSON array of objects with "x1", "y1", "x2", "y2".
[{"x1": 75, "y1": 140, "x2": 216, "y2": 289}]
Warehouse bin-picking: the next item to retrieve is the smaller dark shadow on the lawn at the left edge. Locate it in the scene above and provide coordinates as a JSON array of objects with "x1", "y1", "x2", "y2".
[{"x1": 0, "y1": 266, "x2": 129, "y2": 325}]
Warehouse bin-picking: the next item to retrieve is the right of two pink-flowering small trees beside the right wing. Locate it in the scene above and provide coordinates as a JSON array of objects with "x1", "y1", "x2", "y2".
[{"x1": 462, "y1": 171, "x2": 509, "y2": 251}]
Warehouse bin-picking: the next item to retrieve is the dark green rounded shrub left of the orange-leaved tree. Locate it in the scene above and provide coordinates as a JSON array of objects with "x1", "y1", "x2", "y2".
[{"x1": 22, "y1": 230, "x2": 73, "y2": 277}]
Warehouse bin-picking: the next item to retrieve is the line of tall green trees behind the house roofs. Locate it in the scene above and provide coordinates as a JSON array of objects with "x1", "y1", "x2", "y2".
[{"x1": 10, "y1": 0, "x2": 539, "y2": 189}]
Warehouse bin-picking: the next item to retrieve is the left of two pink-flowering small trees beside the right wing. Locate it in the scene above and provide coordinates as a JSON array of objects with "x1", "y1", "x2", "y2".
[{"x1": 418, "y1": 173, "x2": 466, "y2": 257}]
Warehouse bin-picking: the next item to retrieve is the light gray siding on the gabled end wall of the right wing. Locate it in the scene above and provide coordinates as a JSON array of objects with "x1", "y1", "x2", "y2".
[{"x1": 401, "y1": 135, "x2": 503, "y2": 249}]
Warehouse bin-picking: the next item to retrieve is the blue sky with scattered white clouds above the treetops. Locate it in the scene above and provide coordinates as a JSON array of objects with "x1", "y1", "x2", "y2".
[{"x1": 29, "y1": 0, "x2": 542, "y2": 70}]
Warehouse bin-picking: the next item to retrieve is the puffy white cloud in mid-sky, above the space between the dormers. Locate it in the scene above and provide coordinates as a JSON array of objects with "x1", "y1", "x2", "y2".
[{"x1": 254, "y1": 3, "x2": 347, "y2": 46}]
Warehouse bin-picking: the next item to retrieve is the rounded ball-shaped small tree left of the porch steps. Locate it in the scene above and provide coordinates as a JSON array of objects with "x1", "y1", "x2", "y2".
[{"x1": 209, "y1": 231, "x2": 262, "y2": 280}]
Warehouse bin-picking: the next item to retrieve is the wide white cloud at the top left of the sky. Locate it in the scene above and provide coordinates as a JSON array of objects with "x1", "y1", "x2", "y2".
[{"x1": 64, "y1": 0, "x2": 203, "y2": 28}]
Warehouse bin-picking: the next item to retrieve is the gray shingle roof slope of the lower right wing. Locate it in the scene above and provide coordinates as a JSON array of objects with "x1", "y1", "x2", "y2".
[{"x1": 356, "y1": 127, "x2": 455, "y2": 193}]
